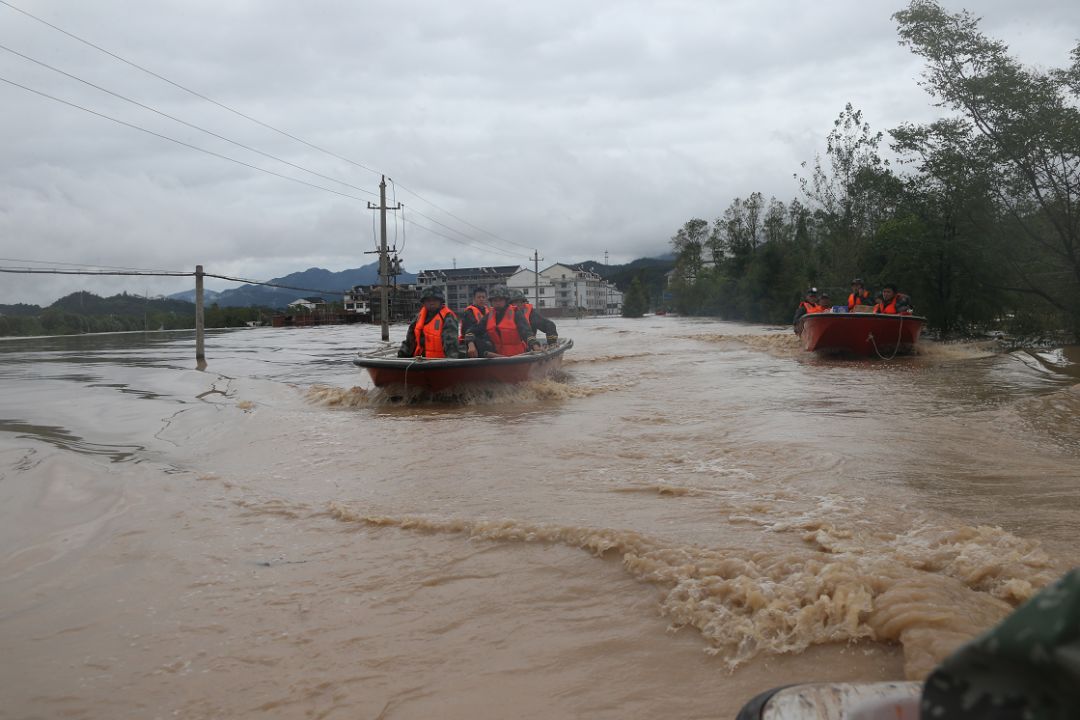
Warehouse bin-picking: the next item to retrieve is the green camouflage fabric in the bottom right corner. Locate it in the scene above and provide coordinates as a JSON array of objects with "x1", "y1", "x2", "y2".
[{"x1": 920, "y1": 569, "x2": 1080, "y2": 720}]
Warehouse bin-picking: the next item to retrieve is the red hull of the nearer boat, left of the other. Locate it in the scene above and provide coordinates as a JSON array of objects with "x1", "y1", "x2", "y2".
[{"x1": 353, "y1": 340, "x2": 573, "y2": 393}]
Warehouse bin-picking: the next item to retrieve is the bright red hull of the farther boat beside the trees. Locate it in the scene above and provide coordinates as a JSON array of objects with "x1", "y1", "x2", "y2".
[{"x1": 795, "y1": 312, "x2": 927, "y2": 358}]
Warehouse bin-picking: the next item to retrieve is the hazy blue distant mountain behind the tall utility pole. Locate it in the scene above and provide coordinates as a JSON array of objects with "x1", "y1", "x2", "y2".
[{"x1": 168, "y1": 261, "x2": 416, "y2": 308}]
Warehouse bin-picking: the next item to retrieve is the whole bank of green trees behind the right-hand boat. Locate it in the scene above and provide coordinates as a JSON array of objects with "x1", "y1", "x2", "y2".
[{"x1": 672, "y1": 0, "x2": 1080, "y2": 335}]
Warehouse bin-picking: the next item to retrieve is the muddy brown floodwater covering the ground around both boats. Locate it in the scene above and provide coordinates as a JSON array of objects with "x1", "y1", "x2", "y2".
[{"x1": 0, "y1": 317, "x2": 1080, "y2": 719}]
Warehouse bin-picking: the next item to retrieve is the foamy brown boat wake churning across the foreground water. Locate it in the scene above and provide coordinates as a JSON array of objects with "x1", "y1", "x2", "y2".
[{"x1": 329, "y1": 496, "x2": 1053, "y2": 679}]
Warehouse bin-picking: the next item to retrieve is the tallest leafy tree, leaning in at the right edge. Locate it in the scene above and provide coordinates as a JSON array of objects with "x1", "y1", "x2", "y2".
[{"x1": 893, "y1": 0, "x2": 1080, "y2": 329}]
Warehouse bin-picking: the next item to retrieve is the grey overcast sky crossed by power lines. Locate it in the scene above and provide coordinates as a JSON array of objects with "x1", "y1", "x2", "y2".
[{"x1": 0, "y1": 0, "x2": 1080, "y2": 303}]
